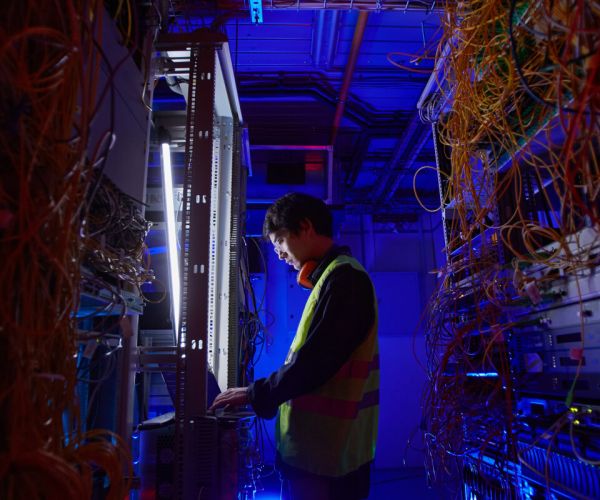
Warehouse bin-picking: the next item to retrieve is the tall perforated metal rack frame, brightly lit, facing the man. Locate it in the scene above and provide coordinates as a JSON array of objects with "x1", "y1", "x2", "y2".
[{"x1": 151, "y1": 30, "x2": 252, "y2": 499}]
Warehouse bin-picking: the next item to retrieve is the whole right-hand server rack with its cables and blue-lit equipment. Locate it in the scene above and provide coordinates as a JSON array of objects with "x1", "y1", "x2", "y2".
[{"x1": 419, "y1": 1, "x2": 600, "y2": 498}]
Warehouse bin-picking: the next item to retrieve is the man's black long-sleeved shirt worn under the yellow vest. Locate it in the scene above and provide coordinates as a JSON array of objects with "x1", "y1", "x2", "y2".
[{"x1": 248, "y1": 247, "x2": 375, "y2": 418}]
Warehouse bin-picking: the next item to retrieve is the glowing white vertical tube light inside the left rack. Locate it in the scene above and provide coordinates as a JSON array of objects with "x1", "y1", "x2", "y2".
[{"x1": 161, "y1": 142, "x2": 181, "y2": 340}]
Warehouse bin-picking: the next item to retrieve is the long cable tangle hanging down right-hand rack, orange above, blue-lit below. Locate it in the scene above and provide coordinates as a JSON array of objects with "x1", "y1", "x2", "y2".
[{"x1": 422, "y1": 0, "x2": 600, "y2": 492}]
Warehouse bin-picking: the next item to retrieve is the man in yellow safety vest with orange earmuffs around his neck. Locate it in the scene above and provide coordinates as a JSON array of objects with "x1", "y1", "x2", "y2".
[{"x1": 211, "y1": 193, "x2": 379, "y2": 500}]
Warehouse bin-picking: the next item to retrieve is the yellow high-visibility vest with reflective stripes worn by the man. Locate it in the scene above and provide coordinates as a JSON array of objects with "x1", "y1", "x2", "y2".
[{"x1": 276, "y1": 255, "x2": 379, "y2": 477}]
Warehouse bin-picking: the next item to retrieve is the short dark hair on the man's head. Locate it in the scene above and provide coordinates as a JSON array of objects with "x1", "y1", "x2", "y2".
[{"x1": 263, "y1": 193, "x2": 333, "y2": 238}]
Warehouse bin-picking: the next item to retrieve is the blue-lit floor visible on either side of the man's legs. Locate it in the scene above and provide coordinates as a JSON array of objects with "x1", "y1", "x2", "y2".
[{"x1": 255, "y1": 467, "x2": 449, "y2": 500}]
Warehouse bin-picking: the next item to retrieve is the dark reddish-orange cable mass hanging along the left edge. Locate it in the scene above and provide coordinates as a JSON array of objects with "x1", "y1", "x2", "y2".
[{"x1": 0, "y1": 0, "x2": 130, "y2": 500}]
